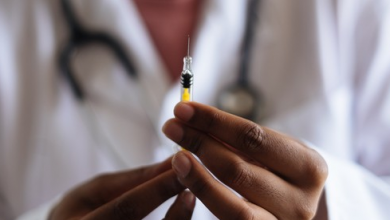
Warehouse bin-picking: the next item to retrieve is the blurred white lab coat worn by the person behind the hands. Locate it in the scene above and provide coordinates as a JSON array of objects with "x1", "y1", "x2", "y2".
[{"x1": 0, "y1": 0, "x2": 390, "y2": 220}]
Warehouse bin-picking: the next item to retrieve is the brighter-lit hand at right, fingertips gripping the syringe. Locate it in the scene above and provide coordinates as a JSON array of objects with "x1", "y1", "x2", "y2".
[{"x1": 163, "y1": 102, "x2": 327, "y2": 220}]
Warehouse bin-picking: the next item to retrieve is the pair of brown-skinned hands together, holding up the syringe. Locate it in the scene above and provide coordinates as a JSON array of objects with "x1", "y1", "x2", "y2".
[{"x1": 50, "y1": 102, "x2": 327, "y2": 220}]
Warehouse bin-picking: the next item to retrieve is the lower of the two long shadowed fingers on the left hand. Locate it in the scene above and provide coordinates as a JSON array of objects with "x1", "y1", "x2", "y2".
[{"x1": 86, "y1": 170, "x2": 184, "y2": 220}]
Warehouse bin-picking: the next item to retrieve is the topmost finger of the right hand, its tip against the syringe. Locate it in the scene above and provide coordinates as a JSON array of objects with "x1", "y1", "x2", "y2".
[{"x1": 175, "y1": 102, "x2": 327, "y2": 183}]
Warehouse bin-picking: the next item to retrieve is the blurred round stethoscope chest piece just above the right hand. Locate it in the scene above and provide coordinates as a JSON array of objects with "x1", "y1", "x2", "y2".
[{"x1": 217, "y1": 84, "x2": 263, "y2": 121}]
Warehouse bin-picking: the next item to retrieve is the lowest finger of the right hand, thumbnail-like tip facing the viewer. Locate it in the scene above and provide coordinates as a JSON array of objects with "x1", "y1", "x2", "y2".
[{"x1": 172, "y1": 151, "x2": 276, "y2": 219}]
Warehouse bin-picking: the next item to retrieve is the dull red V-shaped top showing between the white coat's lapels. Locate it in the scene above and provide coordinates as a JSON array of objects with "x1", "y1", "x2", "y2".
[{"x1": 134, "y1": 0, "x2": 204, "y2": 82}]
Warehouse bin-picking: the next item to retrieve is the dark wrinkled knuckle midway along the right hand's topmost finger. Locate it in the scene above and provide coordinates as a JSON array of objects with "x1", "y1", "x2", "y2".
[{"x1": 237, "y1": 123, "x2": 265, "y2": 151}]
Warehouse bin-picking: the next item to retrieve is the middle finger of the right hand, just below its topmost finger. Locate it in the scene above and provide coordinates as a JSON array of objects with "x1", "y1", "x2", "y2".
[{"x1": 166, "y1": 120, "x2": 305, "y2": 218}]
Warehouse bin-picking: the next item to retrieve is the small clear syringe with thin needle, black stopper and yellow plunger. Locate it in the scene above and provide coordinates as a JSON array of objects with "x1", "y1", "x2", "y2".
[{"x1": 180, "y1": 36, "x2": 194, "y2": 101}]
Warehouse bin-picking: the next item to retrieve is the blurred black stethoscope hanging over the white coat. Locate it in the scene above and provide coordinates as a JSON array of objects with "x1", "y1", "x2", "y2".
[{"x1": 59, "y1": 0, "x2": 263, "y2": 121}]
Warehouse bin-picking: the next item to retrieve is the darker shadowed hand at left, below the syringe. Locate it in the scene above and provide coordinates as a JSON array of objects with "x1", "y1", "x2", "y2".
[{"x1": 50, "y1": 159, "x2": 195, "y2": 220}]
